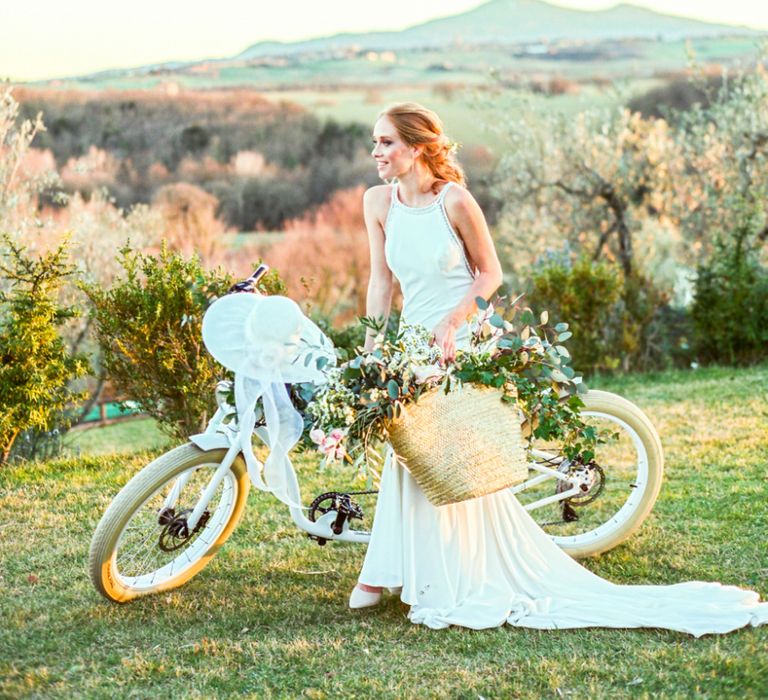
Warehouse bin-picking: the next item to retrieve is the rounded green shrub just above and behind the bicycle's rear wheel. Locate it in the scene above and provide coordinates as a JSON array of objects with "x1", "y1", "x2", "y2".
[{"x1": 529, "y1": 255, "x2": 667, "y2": 374}]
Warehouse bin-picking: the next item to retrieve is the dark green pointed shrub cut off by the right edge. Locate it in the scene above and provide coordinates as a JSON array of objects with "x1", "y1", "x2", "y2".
[{"x1": 691, "y1": 208, "x2": 768, "y2": 364}]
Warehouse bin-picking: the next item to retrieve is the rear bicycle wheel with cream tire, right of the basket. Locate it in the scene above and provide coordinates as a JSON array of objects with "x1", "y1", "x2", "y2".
[{"x1": 513, "y1": 391, "x2": 664, "y2": 557}]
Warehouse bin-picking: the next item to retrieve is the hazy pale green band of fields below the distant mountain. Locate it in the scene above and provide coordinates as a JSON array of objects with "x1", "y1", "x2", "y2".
[{"x1": 47, "y1": 36, "x2": 760, "y2": 91}]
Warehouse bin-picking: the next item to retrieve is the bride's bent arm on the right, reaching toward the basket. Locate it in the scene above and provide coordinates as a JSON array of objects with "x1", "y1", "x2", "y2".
[{"x1": 433, "y1": 187, "x2": 502, "y2": 361}]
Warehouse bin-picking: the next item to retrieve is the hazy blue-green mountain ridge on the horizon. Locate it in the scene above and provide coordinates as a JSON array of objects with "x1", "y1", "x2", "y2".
[{"x1": 48, "y1": 0, "x2": 760, "y2": 89}]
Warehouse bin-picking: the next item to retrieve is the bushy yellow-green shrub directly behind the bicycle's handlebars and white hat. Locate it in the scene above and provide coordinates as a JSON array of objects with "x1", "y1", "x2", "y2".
[{"x1": 84, "y1": 246, "x2": 284, "y2": 439}]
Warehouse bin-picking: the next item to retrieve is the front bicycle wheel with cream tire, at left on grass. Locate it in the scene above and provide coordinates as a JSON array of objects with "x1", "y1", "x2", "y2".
[{"x1": 89, "y1": 443, "x2": 250, "y2": 603}]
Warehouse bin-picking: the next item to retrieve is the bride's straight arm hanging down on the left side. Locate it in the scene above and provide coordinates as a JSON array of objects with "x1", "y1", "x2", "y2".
[{"x1": 363, "y1": 185, "x2": 393, "y2": 350}]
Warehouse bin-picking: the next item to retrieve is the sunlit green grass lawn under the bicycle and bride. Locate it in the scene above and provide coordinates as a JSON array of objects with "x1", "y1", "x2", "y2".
[{"x1": 0, "y1": 365, "x2": 768, "y2": 698}]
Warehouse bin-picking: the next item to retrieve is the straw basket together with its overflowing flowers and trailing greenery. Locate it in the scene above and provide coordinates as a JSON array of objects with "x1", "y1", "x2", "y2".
[{"x1": 299, "y1": 297, "x2": 597, "y2": 505}]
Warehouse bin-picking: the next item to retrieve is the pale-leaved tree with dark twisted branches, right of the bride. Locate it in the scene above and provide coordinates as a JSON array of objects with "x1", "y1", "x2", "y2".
[{"x1": 497, "y1": 108, "x2": 682, "y2": 278}]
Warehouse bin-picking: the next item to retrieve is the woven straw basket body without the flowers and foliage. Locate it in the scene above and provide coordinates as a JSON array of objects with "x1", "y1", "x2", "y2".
[{"x1": 388, "y1": 384, "x2": 528, "y2": 506}]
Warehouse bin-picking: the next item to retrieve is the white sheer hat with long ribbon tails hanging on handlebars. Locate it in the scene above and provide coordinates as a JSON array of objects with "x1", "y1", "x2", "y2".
[{"x1": 203, "y1": 293, "x2": 336, "y2": 507}]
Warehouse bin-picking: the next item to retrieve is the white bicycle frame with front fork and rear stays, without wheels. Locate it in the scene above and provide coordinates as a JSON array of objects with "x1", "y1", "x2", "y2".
[{"x1": 163, "y1": 403, "x2": 588, "y2": 543}]
